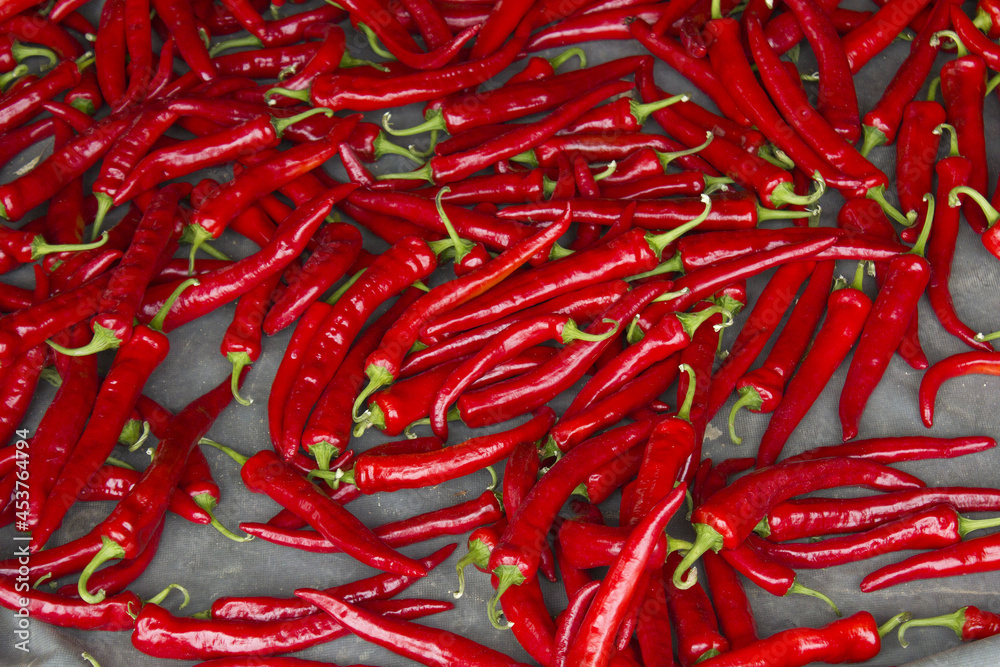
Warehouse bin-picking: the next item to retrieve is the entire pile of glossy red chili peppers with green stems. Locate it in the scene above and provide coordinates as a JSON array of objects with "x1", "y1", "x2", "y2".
[{"x1": 0, "y1": 0, "x2": 1000, "y2": 667}]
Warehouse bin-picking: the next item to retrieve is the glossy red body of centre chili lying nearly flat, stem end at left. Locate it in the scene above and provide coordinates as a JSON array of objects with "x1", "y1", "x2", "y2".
[{"x1": 354, "y1": 408, "x2": 555, "y2": 493}]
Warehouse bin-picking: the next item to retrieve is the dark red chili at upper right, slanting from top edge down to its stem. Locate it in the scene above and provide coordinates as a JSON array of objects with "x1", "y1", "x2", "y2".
[{"x1": 861, "y1": 0, "x2": 961, "y2": 155}]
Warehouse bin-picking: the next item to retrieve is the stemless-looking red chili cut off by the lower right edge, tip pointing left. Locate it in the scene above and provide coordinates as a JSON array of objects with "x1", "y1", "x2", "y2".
[{"x1": 861, "y1": 533, "x2": 1000, "y2": 593}]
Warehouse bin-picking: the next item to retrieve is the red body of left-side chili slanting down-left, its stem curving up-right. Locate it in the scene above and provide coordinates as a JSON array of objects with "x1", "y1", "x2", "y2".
[{"x1": 31, "y1": 327, "x2": 169, "y2": 553}]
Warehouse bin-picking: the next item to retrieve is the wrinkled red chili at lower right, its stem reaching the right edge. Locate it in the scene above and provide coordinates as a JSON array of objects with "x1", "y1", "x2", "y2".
[{"x1": 756, "y1": 505, "x2": 998, "y2": 569}]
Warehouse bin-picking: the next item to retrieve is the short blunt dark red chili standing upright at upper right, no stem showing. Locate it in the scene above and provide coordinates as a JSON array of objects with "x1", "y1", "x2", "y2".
[{"x1": 896, "y1": 100, "x2": 946, "y2": 222}]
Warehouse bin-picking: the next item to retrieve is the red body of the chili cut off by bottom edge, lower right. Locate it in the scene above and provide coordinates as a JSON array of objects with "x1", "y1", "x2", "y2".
[{"x1": 701, "y1": 611, "x2": 882, "y2": 667}]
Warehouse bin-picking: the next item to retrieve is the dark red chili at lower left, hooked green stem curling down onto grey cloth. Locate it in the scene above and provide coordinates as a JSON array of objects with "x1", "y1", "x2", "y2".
[{"x1": 77, "y1": 370, "x2": 240, "y2": 604}]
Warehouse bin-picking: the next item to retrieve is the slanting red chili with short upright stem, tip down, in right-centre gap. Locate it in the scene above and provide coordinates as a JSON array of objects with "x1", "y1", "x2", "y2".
[{"x1": 757, "y1": 266, "x2": 872, "y2": 466}]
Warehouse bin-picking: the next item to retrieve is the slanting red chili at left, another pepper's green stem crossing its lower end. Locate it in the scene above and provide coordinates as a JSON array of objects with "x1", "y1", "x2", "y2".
[{"x1": 139, "y1": 184, "x2": 355, "y2": 331}]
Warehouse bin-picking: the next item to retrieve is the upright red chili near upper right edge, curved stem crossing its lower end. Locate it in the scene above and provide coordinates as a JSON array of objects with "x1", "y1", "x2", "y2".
[{"x1": 941, "y1": 56, "x2": 990, "y2": 234}]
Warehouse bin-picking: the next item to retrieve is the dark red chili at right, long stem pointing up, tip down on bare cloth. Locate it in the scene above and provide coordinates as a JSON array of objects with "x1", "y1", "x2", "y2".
[{"x1": 840, "y1": 195, "x2": 934, "y2": 441}]
